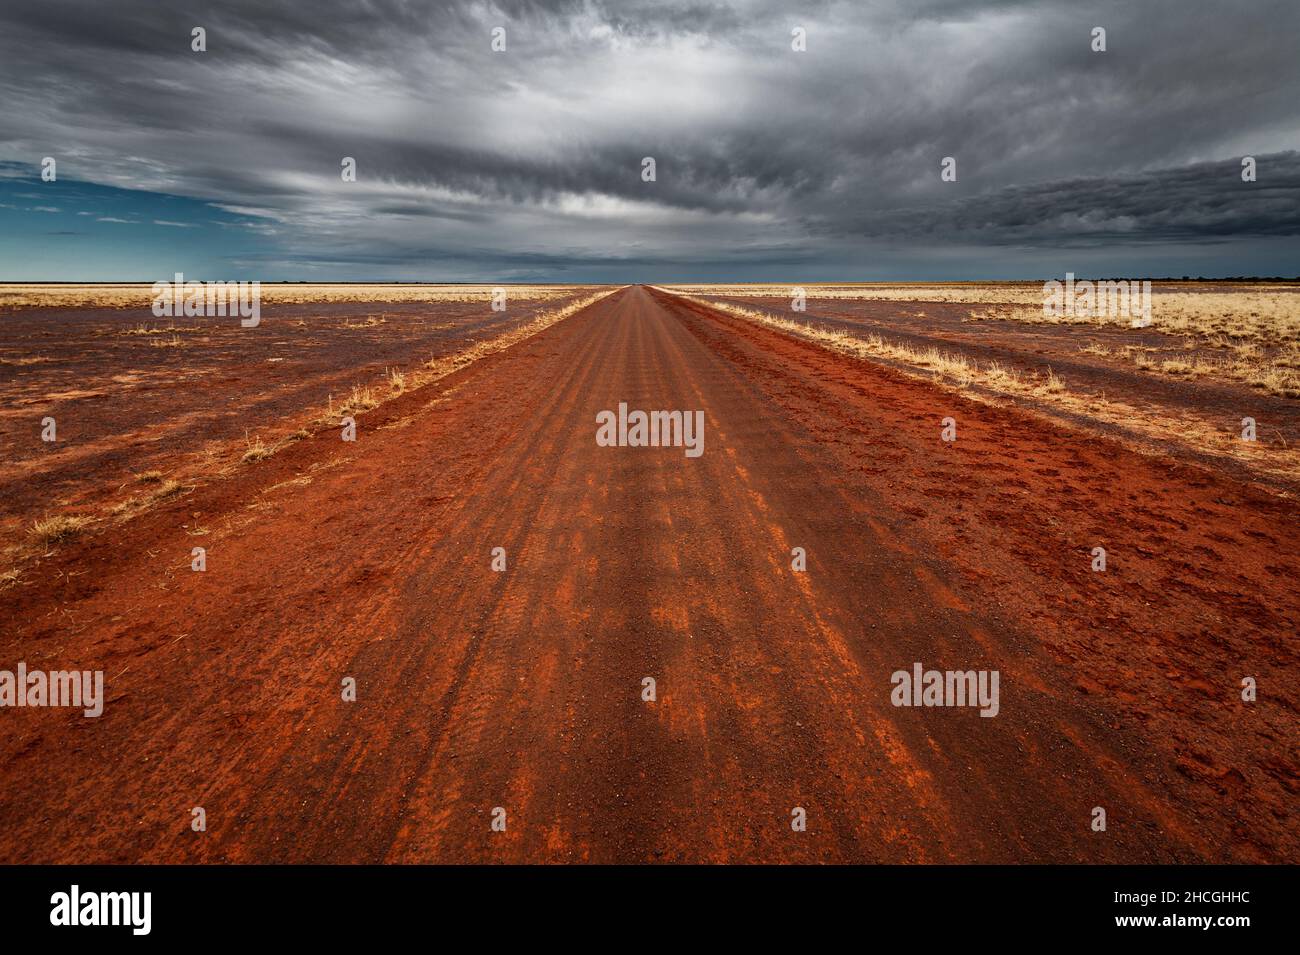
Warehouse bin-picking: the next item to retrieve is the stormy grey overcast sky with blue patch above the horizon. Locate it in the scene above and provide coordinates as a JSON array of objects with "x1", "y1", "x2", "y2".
[{"x1": 0, "y1": 0, "x2": 1300, "y2": 282}]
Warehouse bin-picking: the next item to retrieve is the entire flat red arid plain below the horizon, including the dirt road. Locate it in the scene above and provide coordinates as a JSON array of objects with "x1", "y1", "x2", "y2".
[{"x1": 0, "y1": 283, "x2": 1300, "y2": 863}]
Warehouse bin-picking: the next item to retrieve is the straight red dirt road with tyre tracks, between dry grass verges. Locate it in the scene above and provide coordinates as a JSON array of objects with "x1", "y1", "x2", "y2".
[{"x1": 0, "y1": 287, "x2": 1300, "y2": 863}]
